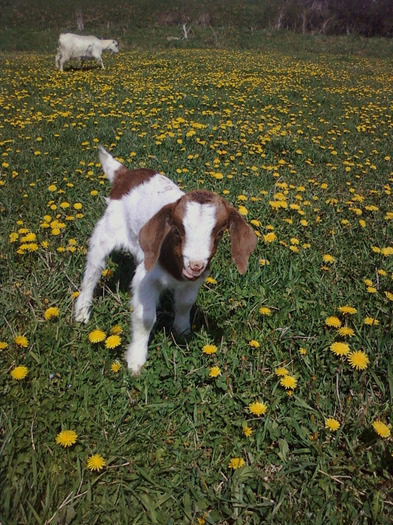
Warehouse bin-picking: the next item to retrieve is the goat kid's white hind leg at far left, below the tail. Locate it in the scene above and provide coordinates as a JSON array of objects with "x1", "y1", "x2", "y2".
[{"x1": 75, "y1": 222, "x2": 115, "y2": 323}]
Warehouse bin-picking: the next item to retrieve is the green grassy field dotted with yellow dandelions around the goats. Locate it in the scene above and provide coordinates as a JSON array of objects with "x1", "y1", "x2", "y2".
[{"x1": 0, "y1": 39, "x2": 393, "y2": 525}]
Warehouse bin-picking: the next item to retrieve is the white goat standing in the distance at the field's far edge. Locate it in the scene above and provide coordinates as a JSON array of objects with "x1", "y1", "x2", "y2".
[{"x1": 55, "y1": 33, "x2": 119, "y2": 71}]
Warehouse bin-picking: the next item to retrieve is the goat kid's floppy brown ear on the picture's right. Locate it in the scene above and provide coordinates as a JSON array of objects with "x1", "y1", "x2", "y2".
[{"x1": 229, "y1": 207, "x2": 258, "y2": 274}]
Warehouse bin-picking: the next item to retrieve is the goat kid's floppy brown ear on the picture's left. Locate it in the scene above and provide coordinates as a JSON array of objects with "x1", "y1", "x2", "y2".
[{"x1": 139, "y1": 204, "x2": 173, "y2": 272}]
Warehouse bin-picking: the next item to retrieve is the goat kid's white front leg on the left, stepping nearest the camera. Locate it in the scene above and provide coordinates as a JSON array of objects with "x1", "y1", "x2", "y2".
[{"x1": 125, "y1": 263, "x2": 161, "y2": 375}]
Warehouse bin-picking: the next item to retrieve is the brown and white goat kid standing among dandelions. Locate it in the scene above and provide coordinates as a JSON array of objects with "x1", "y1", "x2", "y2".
[{"x1": 75, "y1": 146, "x2": 257, "y2": 374}]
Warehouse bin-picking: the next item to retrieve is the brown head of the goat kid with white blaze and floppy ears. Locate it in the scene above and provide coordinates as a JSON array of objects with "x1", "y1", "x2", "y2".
[{"x1": 139, "y1": 190, "x2": 257, "y2": 281}]
